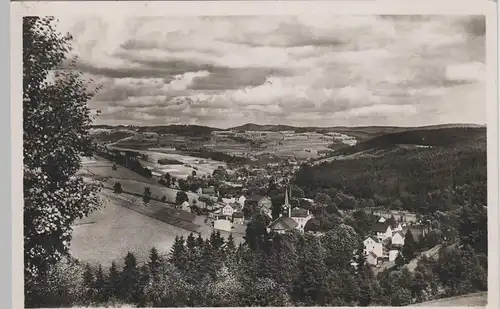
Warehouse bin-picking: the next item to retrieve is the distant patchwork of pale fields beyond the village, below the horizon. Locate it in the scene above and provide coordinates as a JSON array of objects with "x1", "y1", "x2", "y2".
[{"x1": 97, "y1": 130, "x2": 357, "y2": 161}]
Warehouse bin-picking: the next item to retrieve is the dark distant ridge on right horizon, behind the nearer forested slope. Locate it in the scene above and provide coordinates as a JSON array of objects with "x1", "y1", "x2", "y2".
[{"x1": 333, "y1": 127, "x2": 486, "y2": 155}]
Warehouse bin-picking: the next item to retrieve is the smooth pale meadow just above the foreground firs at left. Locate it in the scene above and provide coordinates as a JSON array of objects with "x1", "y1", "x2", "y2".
[{"x1": 71, "y1": 189, "x2": 243, "y2": 267}]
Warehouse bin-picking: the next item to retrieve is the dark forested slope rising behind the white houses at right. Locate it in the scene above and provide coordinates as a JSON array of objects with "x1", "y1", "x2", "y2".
[{"x1": 295, "y1": 141, "x2": 487, "y2": 214}]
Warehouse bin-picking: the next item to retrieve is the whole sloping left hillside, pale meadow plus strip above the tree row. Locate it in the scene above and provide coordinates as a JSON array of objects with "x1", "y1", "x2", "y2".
[{"x1": 71, "y1": 157, "x2": 243, "y2": 266}]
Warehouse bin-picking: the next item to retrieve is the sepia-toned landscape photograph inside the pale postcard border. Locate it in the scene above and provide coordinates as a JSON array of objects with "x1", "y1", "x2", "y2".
[{"x1": 13, "y1": 3, "x2": 498, "y2": 308}]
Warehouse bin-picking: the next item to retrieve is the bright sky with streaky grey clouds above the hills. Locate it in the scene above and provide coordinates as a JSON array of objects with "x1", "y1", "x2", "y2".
[{"x1": 54, "y1": 16, "x2": 486, "y2": 128}]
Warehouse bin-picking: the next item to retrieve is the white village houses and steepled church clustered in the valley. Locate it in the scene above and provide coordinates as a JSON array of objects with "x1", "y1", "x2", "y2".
[{"x1": 172, "y1": 174, "x2": 429, "y2": 269}]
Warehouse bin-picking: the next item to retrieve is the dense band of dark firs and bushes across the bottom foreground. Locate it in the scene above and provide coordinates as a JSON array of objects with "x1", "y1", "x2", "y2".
[{"x1": 26, "y1": 203, "x2": 487, "y2": 307}]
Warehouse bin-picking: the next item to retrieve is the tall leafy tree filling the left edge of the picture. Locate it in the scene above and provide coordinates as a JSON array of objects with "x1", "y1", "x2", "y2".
[{"x1": 23, "y1": 17, "x2": 99, "y2": 280}]
